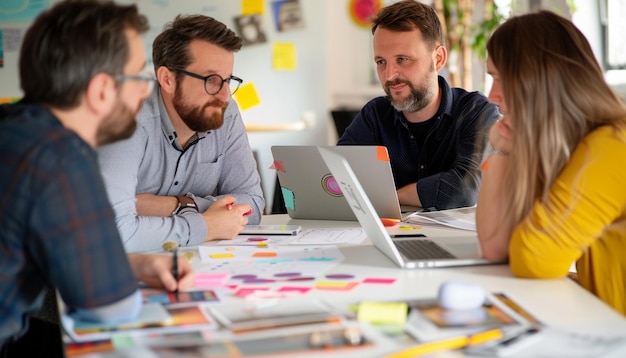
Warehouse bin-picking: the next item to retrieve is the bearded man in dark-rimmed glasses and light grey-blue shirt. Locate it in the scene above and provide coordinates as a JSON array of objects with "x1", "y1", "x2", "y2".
[{"x1": 99, "y1": 15, "x2": 265, "y2": 252}]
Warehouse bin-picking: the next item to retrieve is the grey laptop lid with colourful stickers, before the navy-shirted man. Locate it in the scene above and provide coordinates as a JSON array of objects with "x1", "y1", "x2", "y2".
[{"x1": 272, "y1": 146, "x2": 402, "y2": 220}]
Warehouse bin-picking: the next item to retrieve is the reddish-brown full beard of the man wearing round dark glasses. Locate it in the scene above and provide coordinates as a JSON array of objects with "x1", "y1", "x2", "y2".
[{"x1": 172, "y1": 88, "x2": 228, "y2": 132}]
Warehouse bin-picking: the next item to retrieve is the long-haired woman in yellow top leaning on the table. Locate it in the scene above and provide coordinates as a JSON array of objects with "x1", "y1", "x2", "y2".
[{"x1": 476, "y1": 11, "x2": 626, "y2": 315}]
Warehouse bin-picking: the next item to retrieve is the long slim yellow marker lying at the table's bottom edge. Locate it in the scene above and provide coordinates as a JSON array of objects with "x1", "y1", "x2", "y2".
[{"x1": 386, "y1": 329, "x2": 504, "y2": 358}]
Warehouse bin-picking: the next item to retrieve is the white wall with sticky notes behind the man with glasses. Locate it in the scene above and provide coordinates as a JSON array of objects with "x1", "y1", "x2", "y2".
[{"x1": 0, "y1": 0, "x2": 334, "y2": 213}]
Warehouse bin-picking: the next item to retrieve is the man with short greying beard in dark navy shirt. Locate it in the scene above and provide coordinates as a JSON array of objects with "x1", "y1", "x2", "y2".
[{"x1": 337, "y1": 0, "x2": 499, "y2": 210}]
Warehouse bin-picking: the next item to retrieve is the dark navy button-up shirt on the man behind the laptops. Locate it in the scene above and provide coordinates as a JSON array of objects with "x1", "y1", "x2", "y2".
[{"x1": 337, "y1": 76, "x2": 499, "y2": 210}]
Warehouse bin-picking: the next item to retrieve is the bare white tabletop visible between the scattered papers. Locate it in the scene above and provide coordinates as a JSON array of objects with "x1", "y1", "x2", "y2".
[{"x1": 64, "y1": 215, "x2": 626, "y2": 357}]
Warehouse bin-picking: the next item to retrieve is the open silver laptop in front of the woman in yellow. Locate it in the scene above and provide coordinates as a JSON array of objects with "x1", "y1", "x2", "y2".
[{"x1": 319, "y1": 148, "x2": 496, "y2": 268}]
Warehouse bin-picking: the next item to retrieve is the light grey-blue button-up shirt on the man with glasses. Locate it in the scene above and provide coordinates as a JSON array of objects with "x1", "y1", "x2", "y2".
[{"x1": 97, "y1": 86, "x2": 265, "y2": 252}]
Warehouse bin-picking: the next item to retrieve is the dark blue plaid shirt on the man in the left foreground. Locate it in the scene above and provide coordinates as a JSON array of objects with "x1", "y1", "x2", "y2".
[{"x1": 0, "y1": 102, "x2": 137, "y2": 346}]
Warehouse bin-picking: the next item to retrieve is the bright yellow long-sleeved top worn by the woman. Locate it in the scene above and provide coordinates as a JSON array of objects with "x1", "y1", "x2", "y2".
[{"x1": 509, "y1": 127, "x2": 626, "y2": 315}]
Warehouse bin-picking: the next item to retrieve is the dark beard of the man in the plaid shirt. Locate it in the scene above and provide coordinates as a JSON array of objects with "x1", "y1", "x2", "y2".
[{"x1": 96, "y1": 97, "x2": 136, "y2": 146}]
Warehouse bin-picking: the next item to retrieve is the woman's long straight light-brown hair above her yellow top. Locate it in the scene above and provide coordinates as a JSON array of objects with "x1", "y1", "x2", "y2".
[{"x1": 487, "y1": 11, "x2": 626, "y2": 223}]
